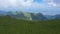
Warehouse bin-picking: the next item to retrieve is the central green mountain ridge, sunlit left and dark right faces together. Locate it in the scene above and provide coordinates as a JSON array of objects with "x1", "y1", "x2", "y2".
[{"x1": 8, "y1": 12, "x2": 46, "y2": 20}]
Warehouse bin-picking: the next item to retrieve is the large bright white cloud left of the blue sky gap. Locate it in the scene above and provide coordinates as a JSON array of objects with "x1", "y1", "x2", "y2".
[{"x1": 0, "y1": 0, "x2": 33, "y2": 8}]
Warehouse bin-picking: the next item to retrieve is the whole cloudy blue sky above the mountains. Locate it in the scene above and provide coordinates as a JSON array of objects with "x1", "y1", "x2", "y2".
[{"x1": 0, "y1": 0, "x2": 60, "y2": 15}]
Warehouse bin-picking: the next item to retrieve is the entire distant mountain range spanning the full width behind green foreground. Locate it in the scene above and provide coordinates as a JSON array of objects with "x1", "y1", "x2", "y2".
[{"x1": 0, "y1": 11, "x2": 60, "y2": 20}]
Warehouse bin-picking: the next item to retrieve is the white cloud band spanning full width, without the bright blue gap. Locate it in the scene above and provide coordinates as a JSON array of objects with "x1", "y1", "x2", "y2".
[{"x1": 0, "y1": 0, "x2": 60, "y2": 8}]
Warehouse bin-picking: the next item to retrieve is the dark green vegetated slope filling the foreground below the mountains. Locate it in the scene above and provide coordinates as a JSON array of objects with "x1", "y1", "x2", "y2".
[{"x1": 0, "y1": 16, "x2": 60, "y2": 34}]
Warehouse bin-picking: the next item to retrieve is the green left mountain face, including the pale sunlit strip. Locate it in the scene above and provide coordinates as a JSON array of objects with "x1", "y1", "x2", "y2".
[{"x1": 8, "y1": 11, "x2": 32, "y2": 20}]
